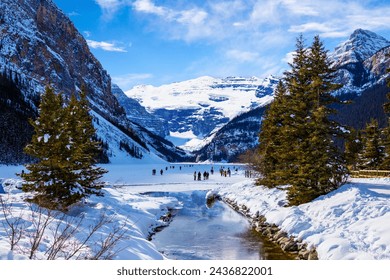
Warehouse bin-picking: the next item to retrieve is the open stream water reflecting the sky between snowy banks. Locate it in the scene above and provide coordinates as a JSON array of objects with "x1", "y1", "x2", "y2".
[{"x1": 150, "y1": 191, "x2": 289, "y2": 260}]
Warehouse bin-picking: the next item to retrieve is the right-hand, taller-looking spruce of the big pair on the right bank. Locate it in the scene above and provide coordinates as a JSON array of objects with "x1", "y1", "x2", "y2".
[{"x1": 291, "y1": 36, "x2": 347, "y2": 203}]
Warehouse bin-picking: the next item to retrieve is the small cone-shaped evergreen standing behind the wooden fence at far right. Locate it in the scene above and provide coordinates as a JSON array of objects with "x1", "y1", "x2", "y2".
[{"x1": 360, "y1": 119, "x2": 384, "y2": 169}]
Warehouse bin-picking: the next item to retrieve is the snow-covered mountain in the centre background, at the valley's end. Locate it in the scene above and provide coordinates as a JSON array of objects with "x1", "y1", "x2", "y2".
[{"x1": 122, "y1": 76, "x2": 278, "y2": 150}]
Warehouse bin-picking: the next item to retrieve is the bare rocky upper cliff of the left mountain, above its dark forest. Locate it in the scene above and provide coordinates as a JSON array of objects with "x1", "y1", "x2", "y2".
[{"x1": 0, "y1": 0, "x2": 123, "y2": 119}]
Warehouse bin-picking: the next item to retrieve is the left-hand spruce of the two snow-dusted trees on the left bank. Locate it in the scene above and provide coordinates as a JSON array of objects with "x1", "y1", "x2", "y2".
[{"x1": 22, "y1": 87, "x2": 68, "y2": 208}]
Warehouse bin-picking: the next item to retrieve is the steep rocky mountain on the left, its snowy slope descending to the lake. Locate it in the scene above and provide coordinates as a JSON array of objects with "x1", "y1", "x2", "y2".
[{"x1": 0, "y1": 0, "x2": 184, "y2": 163}]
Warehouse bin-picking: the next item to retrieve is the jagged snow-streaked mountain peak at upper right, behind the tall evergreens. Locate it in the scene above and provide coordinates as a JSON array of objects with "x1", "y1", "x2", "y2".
[{"x1": 330, "y1": 28, "x2": 390, "y2": 66}]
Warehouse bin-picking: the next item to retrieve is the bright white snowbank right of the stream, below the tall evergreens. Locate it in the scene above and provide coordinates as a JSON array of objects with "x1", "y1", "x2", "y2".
[{"x1": 216, "y1": 179, "x2": 390, "y2": 260}]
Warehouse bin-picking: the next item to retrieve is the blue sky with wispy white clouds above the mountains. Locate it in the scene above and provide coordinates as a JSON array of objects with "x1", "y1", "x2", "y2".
[{"x1": 53, "y1": 0, "x2": 390, "y2": 91}]
